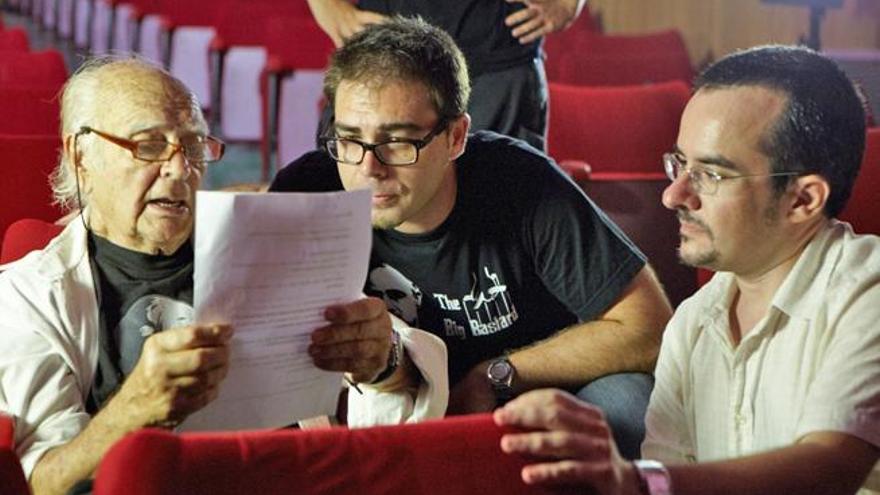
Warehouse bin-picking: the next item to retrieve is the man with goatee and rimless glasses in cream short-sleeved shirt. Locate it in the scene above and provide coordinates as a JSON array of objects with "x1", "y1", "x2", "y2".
[{"x1": 496, "y1": 46, "x2": 880, "y2": 495}]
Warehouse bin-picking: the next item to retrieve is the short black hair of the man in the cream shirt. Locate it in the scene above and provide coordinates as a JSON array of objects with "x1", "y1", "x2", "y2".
[{"x1": 694, "y1": 45, "x2": 865, "y2": 217}]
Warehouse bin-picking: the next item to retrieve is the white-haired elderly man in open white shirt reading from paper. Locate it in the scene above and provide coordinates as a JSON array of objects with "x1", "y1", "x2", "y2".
[{"x1": 0, "y1": 58, "x2": 436, "y2": 494}]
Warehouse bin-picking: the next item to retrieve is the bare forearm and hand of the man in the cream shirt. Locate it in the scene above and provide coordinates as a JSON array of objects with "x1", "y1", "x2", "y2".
[{"x1": 495, "y1": 390, "x2": 880, "y2": 495}]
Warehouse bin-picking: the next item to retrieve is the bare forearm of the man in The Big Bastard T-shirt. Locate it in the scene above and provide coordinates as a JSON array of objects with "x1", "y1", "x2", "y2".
[{"x1": 449, "y1": 266, "x2": 672, "y2": 413}]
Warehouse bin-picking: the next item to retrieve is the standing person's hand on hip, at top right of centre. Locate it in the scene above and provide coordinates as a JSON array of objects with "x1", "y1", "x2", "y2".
[{"x1": 504, "y1": 0, "x2": 584, "y2": 45}]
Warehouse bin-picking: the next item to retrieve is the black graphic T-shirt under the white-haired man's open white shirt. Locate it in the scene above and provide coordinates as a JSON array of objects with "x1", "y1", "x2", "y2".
[{"x1": 87, "y1": 233, "x2": 193, "y2": 413}]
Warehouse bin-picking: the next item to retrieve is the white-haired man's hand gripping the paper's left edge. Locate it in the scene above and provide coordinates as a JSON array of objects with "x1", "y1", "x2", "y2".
[{"x1": 111, "y1": 325, "x2": 232, "y2": 428}]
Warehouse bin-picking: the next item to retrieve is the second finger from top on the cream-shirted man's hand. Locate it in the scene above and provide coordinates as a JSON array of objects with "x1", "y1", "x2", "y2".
[{"x1": 501, "y1": 428, "x2": 611, "y2": 460}]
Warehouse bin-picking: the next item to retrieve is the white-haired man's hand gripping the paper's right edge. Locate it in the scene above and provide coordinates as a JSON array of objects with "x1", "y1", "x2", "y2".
[{"x1": 309, "y1": 297, "x2": 391, "y2": 383}]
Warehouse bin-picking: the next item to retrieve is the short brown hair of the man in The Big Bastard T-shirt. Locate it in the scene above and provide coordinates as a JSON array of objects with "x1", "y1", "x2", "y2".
[{"x1": 324, "y1": 16, "x2": 471, "y2": 121}]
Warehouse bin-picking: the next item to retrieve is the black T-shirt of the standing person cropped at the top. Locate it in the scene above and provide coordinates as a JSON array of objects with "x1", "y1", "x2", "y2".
[{"x1": 358, "y1": 0, "x2": 541, "y2": 77}]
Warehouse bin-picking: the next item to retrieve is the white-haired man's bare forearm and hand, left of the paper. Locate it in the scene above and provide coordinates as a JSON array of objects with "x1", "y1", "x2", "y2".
[{"x1": 30, "y1": 325, "x2": 232, "y2": 495}]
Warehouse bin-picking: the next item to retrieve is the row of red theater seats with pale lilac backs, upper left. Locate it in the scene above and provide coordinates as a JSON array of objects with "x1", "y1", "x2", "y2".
[{"x1": 13, "y1": 0, "x2": 333, "y2": 181}]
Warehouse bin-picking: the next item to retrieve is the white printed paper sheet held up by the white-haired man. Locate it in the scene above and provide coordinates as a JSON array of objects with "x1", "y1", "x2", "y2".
[{"x1": 179, "y1": 190, "x2": 372, "y2": 430}]
